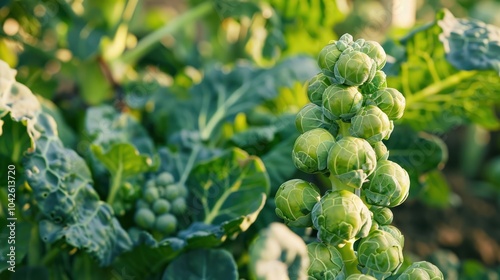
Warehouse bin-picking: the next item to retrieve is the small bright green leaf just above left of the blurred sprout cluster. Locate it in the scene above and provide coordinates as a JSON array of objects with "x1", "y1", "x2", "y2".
[{"x1": 91, "y1": 143, "x2": 155, "y2": 178}]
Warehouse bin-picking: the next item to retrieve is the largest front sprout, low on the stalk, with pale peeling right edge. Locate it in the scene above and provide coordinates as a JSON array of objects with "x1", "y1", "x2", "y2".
[{"x1": 311, "y1": 190, "x2": 372, "y2": 246}]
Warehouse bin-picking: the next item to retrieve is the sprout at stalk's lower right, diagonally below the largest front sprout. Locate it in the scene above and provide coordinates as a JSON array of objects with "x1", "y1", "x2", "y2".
[{"x1": 358, "y1": 230, "x2": 403, "y2": 279}]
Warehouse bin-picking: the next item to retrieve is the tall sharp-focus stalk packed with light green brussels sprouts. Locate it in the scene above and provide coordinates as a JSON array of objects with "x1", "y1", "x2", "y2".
[{"x1": 275, "y1": 34, "x2": 443, "y2": 280}]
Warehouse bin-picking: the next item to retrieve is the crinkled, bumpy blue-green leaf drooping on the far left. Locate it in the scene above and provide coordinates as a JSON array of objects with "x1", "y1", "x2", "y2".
[{"x1": 24, "y1": 113, "x2": 132, "y2": 265}]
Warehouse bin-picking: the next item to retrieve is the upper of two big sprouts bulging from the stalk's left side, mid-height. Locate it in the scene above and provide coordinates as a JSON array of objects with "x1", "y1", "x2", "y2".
[{"x1": 292, "y1": 128, "x2": 335, "y2": 173}]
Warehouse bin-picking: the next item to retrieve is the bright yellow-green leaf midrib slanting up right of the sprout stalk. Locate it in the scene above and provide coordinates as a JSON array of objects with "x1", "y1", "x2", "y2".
[{"x1": 406, "y1": 71, "x2": 477, "y2": 106}]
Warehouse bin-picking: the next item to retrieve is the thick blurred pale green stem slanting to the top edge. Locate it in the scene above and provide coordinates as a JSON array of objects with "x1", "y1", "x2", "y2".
[{"x1": 119, "y1": 1, "x2": 212, "y2": 64}]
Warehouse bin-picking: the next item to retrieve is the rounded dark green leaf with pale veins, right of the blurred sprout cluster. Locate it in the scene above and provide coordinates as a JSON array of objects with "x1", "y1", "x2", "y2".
[{"x1": 188, "y1": 148, "x2": 269, "y2": 225}]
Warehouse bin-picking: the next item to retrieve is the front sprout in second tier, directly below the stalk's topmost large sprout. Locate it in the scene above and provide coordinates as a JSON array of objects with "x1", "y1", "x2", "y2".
[{"x1": 323, "y1": 85, "x2": 363, "y2": 121}]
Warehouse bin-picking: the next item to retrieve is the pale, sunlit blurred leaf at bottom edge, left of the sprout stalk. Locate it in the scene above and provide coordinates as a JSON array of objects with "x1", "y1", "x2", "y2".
[{"x1": 249, "y1": 223, "x2": 309, "y2": 280}]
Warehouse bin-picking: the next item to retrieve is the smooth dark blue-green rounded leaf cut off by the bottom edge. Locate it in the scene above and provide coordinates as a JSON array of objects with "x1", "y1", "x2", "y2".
[{"x1": 162, "y1": 250, "x2": 238, "y2": 280}]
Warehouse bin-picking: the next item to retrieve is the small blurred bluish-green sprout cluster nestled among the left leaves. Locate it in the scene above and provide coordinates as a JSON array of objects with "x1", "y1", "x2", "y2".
[{"x1": 134, "y1": 172, "x2": 188, "y2": 235}]
